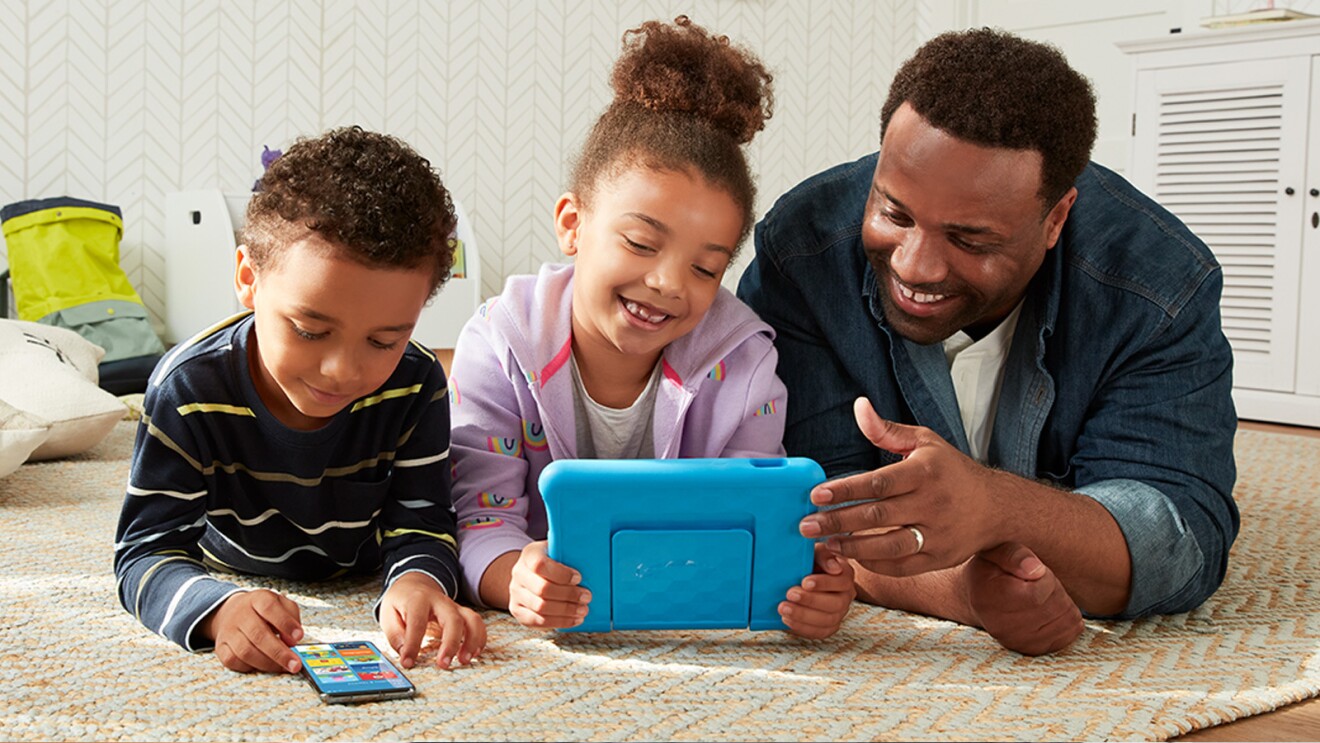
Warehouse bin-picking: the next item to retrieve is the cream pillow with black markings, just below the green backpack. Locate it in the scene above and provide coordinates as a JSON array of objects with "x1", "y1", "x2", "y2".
[{"x1": 0, "y1": 319, "x2": 125, "y2": 459}]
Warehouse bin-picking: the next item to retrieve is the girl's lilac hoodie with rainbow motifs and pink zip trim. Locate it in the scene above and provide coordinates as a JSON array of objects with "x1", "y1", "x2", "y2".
[{"x1": 449, "y1": 265, "x2": 787, "y2": 603}]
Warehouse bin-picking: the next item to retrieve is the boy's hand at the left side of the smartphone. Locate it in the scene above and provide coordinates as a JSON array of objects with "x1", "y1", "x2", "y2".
[{"x1": 198, "y1": 589, "x2": 302, "y2": 673}]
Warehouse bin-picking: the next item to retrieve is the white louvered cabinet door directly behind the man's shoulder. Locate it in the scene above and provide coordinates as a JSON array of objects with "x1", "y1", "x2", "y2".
[{"x1": 1131, "y1": 55, "x2": 1320, "y2": 395}]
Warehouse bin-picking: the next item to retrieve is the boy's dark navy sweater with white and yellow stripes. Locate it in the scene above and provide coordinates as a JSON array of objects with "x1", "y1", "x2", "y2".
[{"x1": 115, "y1": 314, "x2": 458, "y2": 651}]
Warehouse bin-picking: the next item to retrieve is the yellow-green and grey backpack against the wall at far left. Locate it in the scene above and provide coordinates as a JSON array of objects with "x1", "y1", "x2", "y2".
[{"x1": 0, "y1": 197, "x2": 165, "y2": 395}]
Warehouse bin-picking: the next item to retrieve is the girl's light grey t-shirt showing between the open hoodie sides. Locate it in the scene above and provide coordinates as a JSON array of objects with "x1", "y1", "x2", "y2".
[{"x1": 570, "y1": 356, "x2": 660, "y2": 459}]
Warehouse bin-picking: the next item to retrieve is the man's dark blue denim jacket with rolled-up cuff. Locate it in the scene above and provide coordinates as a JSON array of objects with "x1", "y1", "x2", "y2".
[{"x1": 738, "y1": 153, "x2": 1238, "y2": 618}]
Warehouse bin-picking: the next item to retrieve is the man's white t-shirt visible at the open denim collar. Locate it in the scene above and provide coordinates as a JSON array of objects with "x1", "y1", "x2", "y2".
[{"x1": 944, "y1": 302, "x2": 1022, "y2": 465}]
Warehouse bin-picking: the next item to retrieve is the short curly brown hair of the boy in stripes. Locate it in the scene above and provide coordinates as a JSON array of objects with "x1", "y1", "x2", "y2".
[{"x1": 243, "y1": 127, "x2": 457, "y2": 293}]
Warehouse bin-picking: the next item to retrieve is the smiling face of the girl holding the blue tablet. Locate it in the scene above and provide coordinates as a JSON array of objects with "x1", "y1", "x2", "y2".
[{"x1": 554, "y1": 165, "x2": 743, "y2": 368}]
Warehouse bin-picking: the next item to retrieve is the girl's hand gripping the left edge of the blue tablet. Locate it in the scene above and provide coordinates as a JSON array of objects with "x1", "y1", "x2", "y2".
[{"x1": 508, "y1": 540, "x2": 591, "y2": 627}]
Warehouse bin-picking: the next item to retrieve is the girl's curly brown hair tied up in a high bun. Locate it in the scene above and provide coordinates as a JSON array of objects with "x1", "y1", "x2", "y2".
[{"x1": 569, "y1": 16, "x2": 775, "y2": 243}]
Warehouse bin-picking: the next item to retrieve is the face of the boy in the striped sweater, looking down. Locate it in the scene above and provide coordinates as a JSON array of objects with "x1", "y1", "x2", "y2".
[{"x1": 234, "y1": 231, "x2": 432, "y2": 430}]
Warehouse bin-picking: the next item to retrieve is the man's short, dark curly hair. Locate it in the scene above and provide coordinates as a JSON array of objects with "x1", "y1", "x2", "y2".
[{"x1": 880, "y1": 28, "x2": 1096, "y2": 205}]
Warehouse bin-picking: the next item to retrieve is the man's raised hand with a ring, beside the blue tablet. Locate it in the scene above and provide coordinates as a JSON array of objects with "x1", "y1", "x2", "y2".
[{"x1": 800, "y1": 397, "x2": 1007, "y2": 575}]
